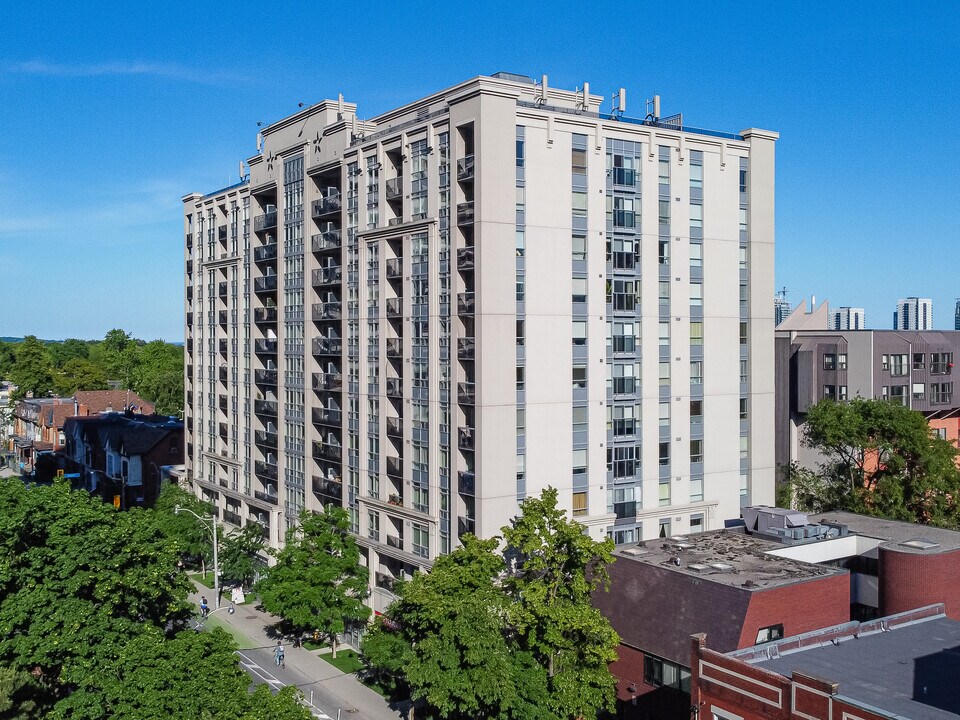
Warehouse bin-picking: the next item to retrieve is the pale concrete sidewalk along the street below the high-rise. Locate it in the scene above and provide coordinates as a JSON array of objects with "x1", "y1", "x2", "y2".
[{"x1": 190, "y1": 581, "x2": 406, "y2": 720}]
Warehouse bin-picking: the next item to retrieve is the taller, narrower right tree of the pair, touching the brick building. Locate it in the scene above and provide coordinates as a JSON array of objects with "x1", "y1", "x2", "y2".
[{"x1": 503, "y1": 488, "x2": 619, "y2": 718}]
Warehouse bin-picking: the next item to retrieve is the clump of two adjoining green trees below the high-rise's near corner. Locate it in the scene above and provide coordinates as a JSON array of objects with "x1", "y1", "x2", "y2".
[{"x1": 362, "y1": 488, "x2": 619, "y2": 720}]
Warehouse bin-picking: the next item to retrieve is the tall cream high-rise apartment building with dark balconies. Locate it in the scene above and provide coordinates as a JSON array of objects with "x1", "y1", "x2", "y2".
[{"x1": 183, "y1": 73, "x2": 777, "y2": 609}]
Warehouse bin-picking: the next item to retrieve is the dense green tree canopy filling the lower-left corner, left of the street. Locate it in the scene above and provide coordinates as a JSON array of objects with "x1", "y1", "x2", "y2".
[{"x1": 0, "y1": 480, "x2": 311, "y2": 720}]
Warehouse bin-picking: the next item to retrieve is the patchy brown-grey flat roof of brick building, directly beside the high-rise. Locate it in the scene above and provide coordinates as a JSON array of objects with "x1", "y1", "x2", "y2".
[{"x1": 613, "y1": 529, "x2": 846, "y2": 590}]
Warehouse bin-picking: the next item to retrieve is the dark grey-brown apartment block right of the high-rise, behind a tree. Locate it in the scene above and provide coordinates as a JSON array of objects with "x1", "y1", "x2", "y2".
[{"x1": 775, "y1": 303, "x2": 960, "y2": 467}]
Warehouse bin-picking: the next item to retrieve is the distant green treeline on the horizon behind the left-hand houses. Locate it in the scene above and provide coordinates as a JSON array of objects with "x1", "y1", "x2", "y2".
[{"x1": 0, "y1": 329, "x2": 183, "y2": 415}]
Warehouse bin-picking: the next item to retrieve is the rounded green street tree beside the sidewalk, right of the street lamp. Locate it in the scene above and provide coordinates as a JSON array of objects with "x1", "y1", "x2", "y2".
[{"x1": 256, "y1": 506, "x2": 370, "y2": 657}]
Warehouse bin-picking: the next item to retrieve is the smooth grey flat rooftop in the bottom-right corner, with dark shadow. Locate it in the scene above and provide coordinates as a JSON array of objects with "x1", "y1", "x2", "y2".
[{"x1": 755, "y1": 615, "x2": 960, "y2": 720}]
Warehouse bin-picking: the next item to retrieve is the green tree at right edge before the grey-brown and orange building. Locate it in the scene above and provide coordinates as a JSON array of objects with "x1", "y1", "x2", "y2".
[{"x1": 789, "y1": 398, "x2": 960, "y2": 527}]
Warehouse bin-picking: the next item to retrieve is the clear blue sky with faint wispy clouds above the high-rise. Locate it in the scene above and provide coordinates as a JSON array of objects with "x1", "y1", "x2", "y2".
[{"x1": 0, "y1": 0, "x2": 960, "y2": 340}]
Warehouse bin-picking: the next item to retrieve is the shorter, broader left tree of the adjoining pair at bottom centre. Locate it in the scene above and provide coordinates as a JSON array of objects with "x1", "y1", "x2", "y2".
[{"x1": 362, "y1": 535, "x2": 554, "y2": 720}]
